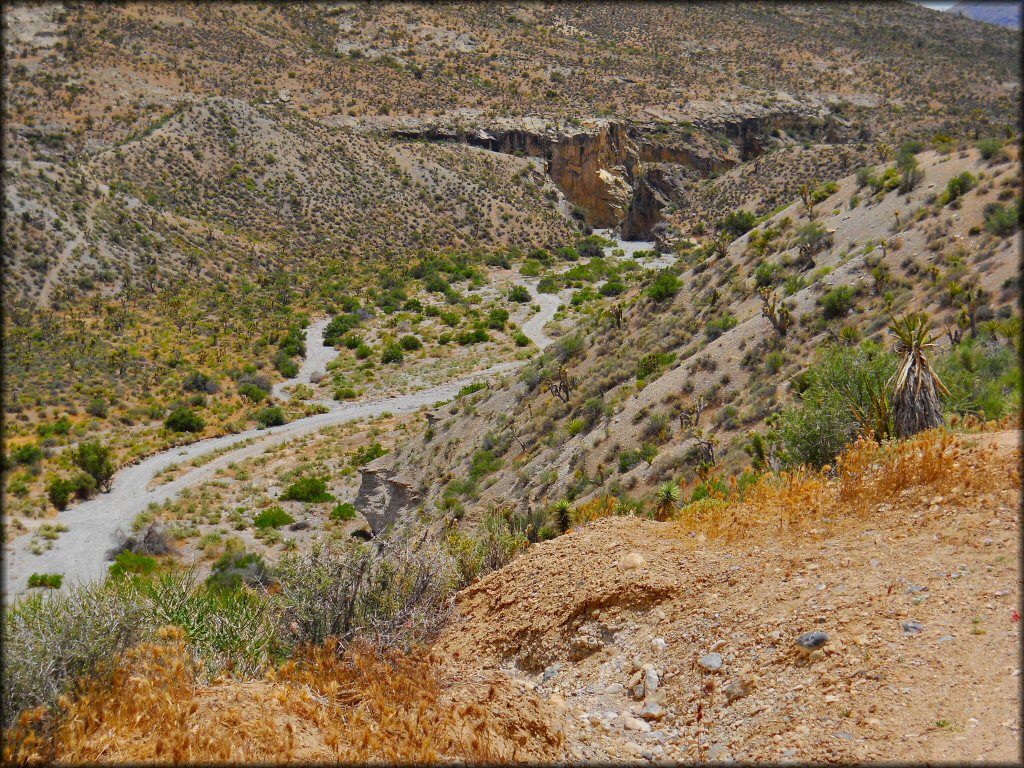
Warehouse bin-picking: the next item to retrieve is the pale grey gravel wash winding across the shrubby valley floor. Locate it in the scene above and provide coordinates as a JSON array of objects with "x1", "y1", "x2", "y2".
[{"x1": 3, "y1": 281, "x2": 561, "y2": 603}]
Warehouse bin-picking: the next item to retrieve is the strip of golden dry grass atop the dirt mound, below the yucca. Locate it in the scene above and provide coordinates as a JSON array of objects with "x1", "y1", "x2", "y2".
[{"x1": 677, "y1": 430, "x2": 1020, "y2": 542}]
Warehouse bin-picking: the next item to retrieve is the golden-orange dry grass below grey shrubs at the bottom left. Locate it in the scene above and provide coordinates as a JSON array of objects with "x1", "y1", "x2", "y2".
[{"x1": 3, "y1": 628, "x2": 561, "y2": 764}]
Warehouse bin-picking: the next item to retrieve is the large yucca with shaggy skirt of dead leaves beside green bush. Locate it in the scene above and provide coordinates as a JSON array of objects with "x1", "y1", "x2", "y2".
[{"x1": 889, "y1": 312, "x2": 949, "y2": 438}]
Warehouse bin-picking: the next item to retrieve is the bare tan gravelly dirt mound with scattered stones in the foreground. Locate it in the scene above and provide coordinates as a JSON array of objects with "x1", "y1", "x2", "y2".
[{"x1": 438, "y1": 432, "x2": 1021, "y2": 762}]
